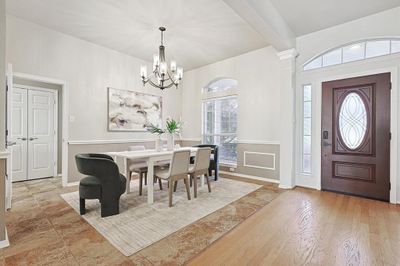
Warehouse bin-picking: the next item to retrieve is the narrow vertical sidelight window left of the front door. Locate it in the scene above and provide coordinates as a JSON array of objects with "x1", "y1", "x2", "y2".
[{"x1": 301, "y1": 85, "x2": 312, "y2": 173}]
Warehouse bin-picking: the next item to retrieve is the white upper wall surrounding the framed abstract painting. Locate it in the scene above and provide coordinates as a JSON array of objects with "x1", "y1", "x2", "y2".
[{"x1": 6, "y1": 16, "x2": 181, "y2": 140}]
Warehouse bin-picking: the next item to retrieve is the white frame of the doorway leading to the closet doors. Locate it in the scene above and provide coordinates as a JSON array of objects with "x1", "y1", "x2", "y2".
[{"x1": 8, "y1": 64, "x2": 69, "y2": 187}]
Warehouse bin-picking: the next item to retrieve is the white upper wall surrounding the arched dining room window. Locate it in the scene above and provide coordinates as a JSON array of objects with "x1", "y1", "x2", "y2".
[{"x1": 182, "y1": 47, "x2": 280, "y2": 142}]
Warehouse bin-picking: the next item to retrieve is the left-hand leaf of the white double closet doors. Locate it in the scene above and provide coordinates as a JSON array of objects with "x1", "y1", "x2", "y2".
[{"x1": 10, "y1": 88, "x2": 28, "y2": 181}]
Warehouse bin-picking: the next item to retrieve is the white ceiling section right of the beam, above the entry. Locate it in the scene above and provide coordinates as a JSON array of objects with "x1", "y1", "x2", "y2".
[{"x1": 268, "y1": 0, "x2": 400, "y2": 36}]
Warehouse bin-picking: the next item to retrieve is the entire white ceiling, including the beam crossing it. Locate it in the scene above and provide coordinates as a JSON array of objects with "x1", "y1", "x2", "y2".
[{"x1": 7, "y1": 0, "x2": 400, "y2": 70}]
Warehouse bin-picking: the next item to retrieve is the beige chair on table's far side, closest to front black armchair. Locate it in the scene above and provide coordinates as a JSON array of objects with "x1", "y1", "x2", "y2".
[{"x1": 126, "y1": 146, "x2": 162, "y2": 195}]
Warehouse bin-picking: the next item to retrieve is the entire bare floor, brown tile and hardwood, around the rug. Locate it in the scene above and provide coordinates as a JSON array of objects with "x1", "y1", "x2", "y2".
[{"x1": 0, "y1": 176, "x2": 400, "y2": 265}]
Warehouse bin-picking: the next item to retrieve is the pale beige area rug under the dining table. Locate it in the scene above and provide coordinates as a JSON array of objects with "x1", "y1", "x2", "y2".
[{"x1": 61, "y1": 178, "x2": 261, "y2": 256}]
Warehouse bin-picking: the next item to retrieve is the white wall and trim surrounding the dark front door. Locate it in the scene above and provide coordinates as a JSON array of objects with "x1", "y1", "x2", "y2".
[{"x1": 296, "y1": 8, "x2": 400, "y2": 202}]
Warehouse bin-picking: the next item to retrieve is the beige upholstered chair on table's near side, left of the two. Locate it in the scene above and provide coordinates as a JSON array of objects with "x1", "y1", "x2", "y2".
[{"x1": 154, "y1": 150, "x2": 190, "y2": 207}]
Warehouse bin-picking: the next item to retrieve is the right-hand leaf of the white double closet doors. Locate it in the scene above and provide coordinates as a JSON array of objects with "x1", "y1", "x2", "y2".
[{"x1": 28, "y1": 90, "x2": 55, "y2": 179}]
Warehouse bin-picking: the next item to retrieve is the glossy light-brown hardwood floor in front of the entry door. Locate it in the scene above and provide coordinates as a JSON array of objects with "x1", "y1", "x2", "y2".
[{"x1": 189, "y1": 188, "x2": 400, "y2": 265}]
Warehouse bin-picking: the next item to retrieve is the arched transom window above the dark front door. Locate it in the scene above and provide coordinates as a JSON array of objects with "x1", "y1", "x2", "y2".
[{"x1": 303, "y1": 39, "x2": 400, "y2": 70}]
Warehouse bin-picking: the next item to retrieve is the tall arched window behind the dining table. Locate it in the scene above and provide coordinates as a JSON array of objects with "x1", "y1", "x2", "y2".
[{"x1": 202, "y1": 79, "x2": 238, "y2": 164}]
